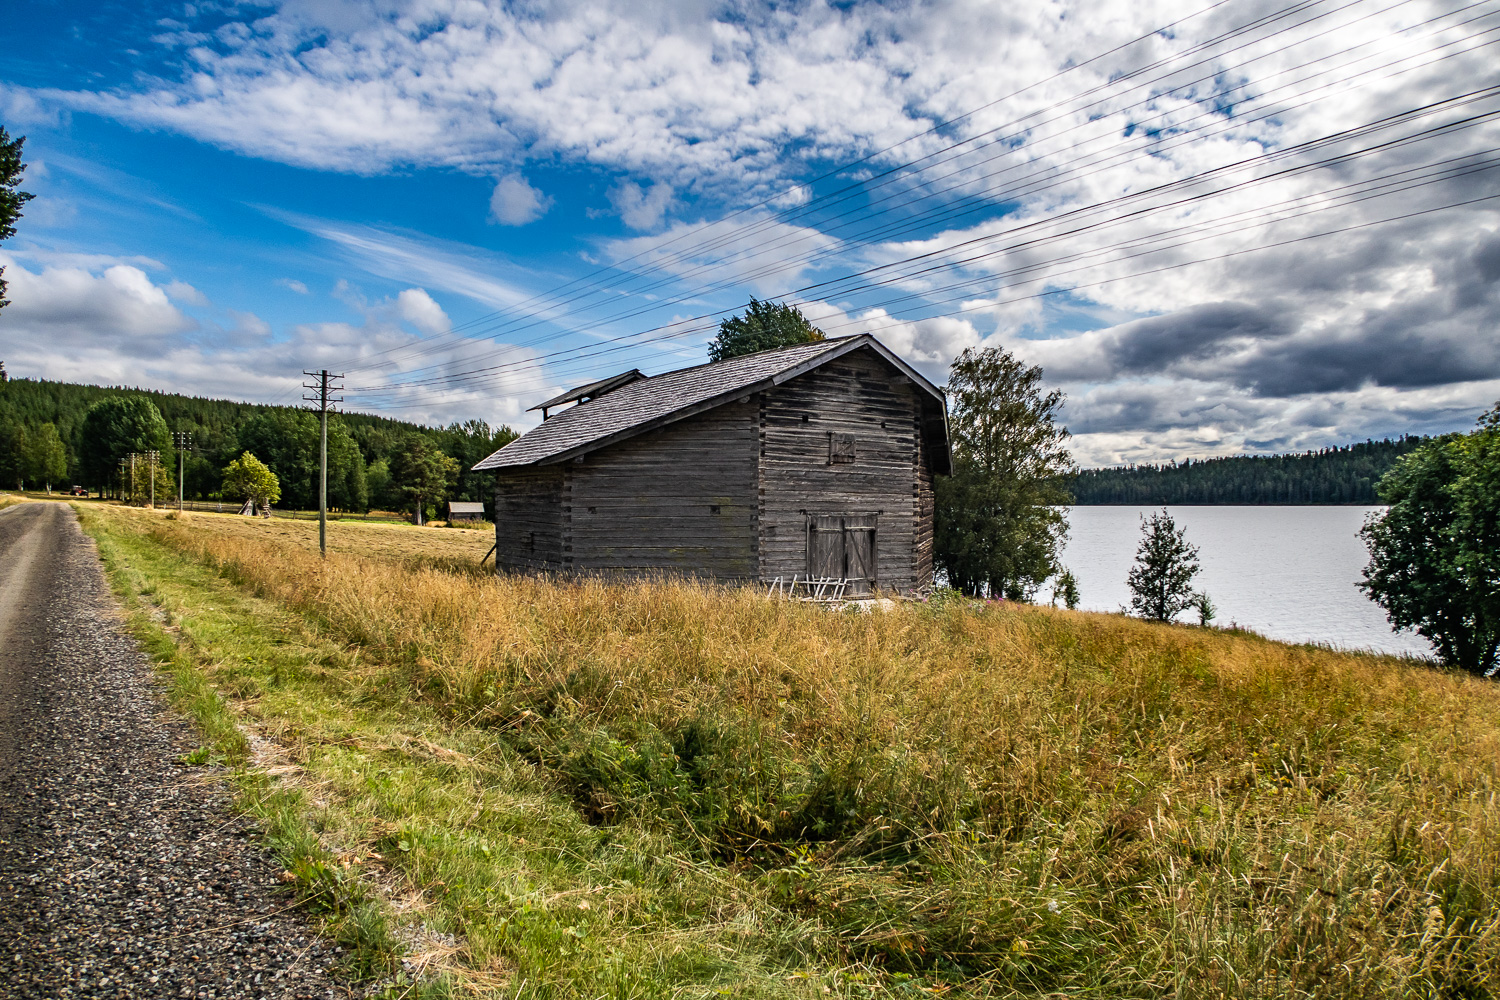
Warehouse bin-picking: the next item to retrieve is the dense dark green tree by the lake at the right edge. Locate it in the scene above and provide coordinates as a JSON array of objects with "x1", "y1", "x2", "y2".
[{"x1": 1359, "y1": 405, "x2": 1500, "y2": 675}]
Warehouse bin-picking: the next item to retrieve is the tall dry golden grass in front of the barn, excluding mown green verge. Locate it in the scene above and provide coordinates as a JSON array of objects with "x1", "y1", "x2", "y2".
[{"x1": 85, "y1": 511, "x2": 1500, "y2": 997}]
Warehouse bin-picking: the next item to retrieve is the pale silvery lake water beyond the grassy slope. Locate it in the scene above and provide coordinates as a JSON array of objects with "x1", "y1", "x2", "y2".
[{"x1": 1056, "y1": 507, "x2": 1433, "y2": 655}]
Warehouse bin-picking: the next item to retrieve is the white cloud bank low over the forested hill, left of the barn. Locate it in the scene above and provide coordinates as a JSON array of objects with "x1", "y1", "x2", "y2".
[{"x1": 0, "y1": 253, "x2": 551, "y2": 423}]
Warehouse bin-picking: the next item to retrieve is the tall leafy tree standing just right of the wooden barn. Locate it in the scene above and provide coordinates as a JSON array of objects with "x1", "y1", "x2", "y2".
[{"x1": 936, "y1": 348, "x2": 1077, "y2": 600}]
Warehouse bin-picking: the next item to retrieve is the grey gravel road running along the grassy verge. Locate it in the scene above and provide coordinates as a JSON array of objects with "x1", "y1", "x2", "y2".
[{"x1": 0, "y1": 502, "x2": 354, "y2": 1000}]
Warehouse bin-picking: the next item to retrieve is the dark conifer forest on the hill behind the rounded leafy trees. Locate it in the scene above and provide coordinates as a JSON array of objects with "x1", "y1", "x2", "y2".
[{"x1": 0, "y1": 378, "x2": 516, "y2": 511}]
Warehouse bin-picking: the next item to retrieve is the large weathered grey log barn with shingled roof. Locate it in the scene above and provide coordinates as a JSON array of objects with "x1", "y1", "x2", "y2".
[{"x1": 474, "y1": 334, "x2": 948, "y2": 594}]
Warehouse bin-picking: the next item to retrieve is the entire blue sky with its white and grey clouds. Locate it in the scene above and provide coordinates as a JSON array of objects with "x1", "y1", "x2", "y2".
[{"x1": 0, "y1": 0, "x2": 1500, "y2": 465}]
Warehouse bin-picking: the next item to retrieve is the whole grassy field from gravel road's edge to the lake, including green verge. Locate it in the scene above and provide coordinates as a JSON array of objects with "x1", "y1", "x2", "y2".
[{"x1": 64, "y1": 504, "x2": 1500, "y2": 999}]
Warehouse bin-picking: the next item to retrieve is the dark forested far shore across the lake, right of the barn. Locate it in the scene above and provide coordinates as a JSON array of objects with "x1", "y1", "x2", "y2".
[{"x1": 1071, "y1": 435, "x2": 1427, "y2": 507}]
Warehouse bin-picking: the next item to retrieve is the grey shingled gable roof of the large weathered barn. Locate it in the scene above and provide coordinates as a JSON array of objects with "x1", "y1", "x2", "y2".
[{"x1": 474, "y1": 333, "x2": 944, "y2": 471}]
